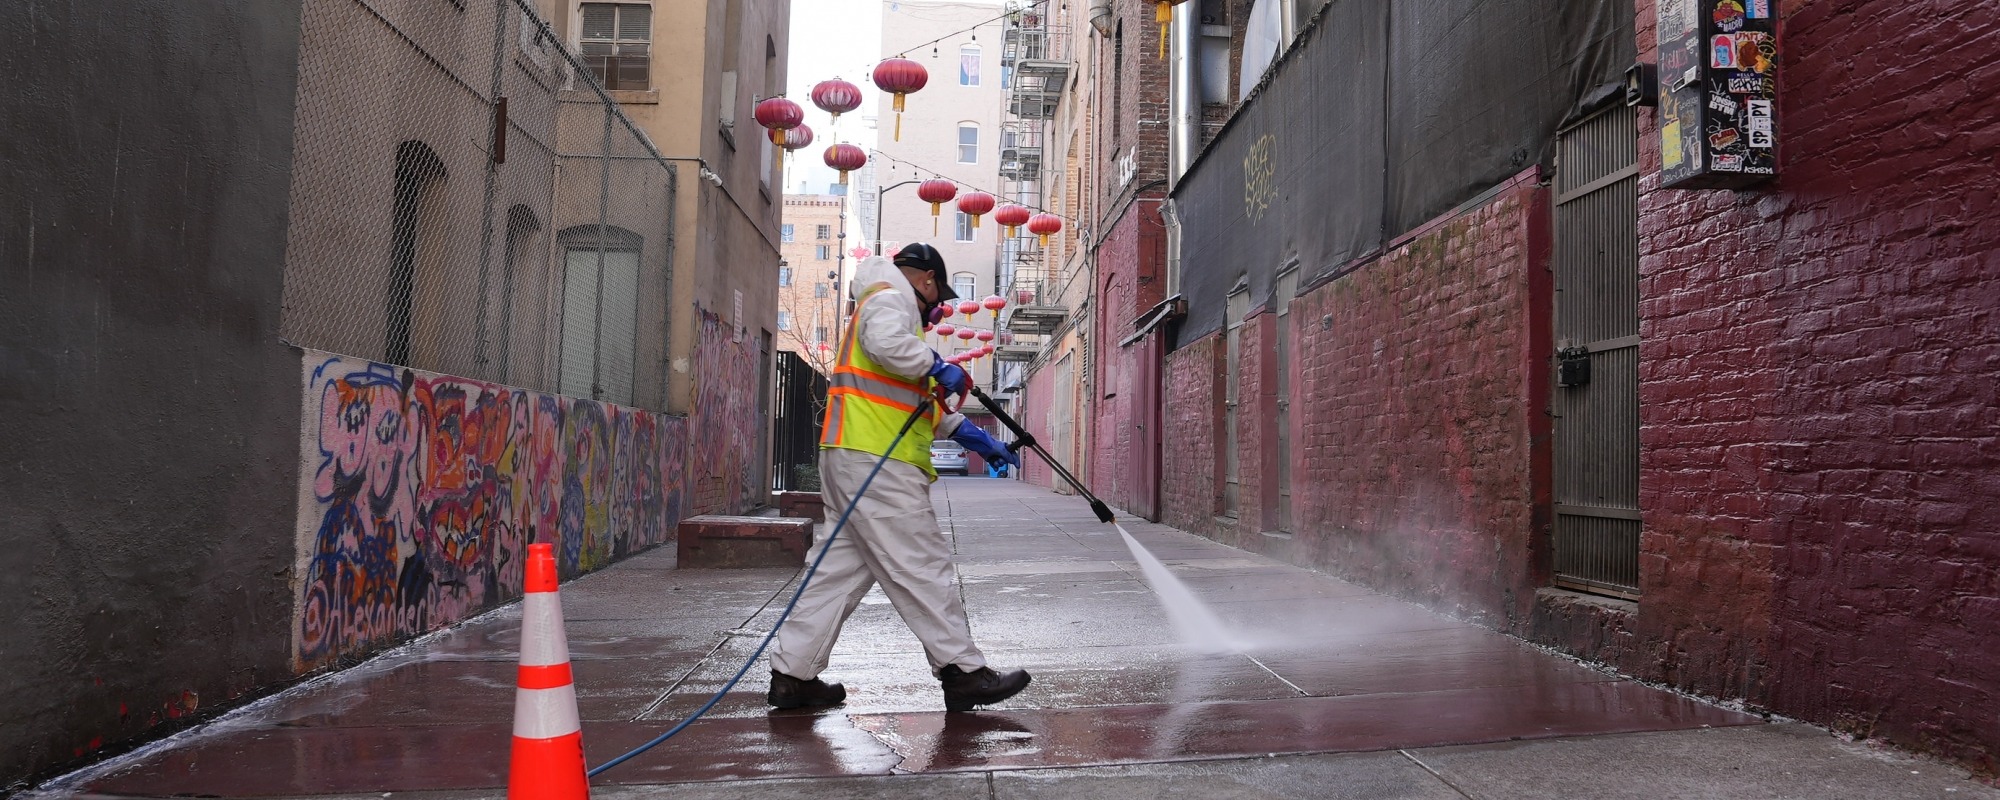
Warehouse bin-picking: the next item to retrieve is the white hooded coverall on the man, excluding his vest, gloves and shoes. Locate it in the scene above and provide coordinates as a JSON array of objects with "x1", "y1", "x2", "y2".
[{"x1": 770, "y1": 256, "x2": 986, "y2": 680}]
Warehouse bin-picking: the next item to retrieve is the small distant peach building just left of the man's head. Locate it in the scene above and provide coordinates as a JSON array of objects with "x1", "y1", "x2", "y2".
[{"x1": 778, "y1": 194, "x2": 848, "y2": 374}]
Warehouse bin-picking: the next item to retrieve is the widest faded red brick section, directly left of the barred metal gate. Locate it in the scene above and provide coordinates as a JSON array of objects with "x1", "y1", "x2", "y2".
[{"x1": 1290, "y1": 184, "x2": 1548, "y2": 624}]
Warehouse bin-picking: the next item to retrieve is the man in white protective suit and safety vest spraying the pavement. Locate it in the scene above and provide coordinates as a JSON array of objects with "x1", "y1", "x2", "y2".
[{"x1": 766, "y1": 242, "x2": 1030, "y2": 712}]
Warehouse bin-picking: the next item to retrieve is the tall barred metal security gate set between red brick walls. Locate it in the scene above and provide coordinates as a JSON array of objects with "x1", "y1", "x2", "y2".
[{"x1": 1552, "y1": 106, "x2": 1640, "y2": 598}]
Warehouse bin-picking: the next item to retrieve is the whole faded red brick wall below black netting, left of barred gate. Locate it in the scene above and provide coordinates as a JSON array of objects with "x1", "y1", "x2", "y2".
[{"x1": 1164, "y1": 180, "x2": 1548, "y2": 628}]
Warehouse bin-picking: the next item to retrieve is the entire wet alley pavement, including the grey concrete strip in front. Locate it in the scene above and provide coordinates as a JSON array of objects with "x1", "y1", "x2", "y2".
[{"x1": 42, "y1": 478, "x2": 2000, "y2": 800}]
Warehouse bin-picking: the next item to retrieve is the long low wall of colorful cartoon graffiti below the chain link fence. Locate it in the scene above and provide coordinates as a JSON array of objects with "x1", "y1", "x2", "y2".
[{"x1": 294, "y1": 350, "x2": 688, "y2": 670}]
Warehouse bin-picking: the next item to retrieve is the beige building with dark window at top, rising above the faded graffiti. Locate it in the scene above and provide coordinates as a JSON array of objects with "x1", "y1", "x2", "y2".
[{"x1": 540, "y1": 0, "x2": 792, "y2": 412}]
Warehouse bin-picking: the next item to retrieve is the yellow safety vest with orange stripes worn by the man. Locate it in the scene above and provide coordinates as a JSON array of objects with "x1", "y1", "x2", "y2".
[{"x1": 820, "y1": 286, "x2": 938, "y2": 480}]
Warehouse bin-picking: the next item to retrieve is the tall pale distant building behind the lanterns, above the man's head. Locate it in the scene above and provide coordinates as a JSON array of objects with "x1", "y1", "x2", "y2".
[{"x1": 872, "y1": 0, "x2": 1008, "y2": 396}]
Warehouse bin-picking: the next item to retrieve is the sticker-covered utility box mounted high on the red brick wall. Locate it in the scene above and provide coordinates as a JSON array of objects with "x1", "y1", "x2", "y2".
[{"x1": 1658, "y1": 0, "x2": 1778, "y2": 188}]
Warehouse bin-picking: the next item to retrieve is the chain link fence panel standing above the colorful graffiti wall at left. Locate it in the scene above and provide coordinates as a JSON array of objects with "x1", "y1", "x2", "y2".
[{"x1": 284, "y1": 0, "x2": 676, "y2": 408}]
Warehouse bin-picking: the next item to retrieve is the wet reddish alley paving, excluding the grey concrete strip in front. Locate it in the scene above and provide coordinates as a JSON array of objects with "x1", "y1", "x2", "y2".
[{"x1": 58, "y1": 478, "x2": 1760, "y2": 796}]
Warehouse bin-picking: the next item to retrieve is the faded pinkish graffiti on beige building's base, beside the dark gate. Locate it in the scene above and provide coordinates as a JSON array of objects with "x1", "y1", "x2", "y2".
[{"x1": 690, "y1": 308, "x2": 770, "y2": 514}]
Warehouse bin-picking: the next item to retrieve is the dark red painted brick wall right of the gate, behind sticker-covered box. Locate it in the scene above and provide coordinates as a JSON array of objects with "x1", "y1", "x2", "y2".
[{"x1": 1618, "y1": 0, "x2": 2000, "y2": 772}]
